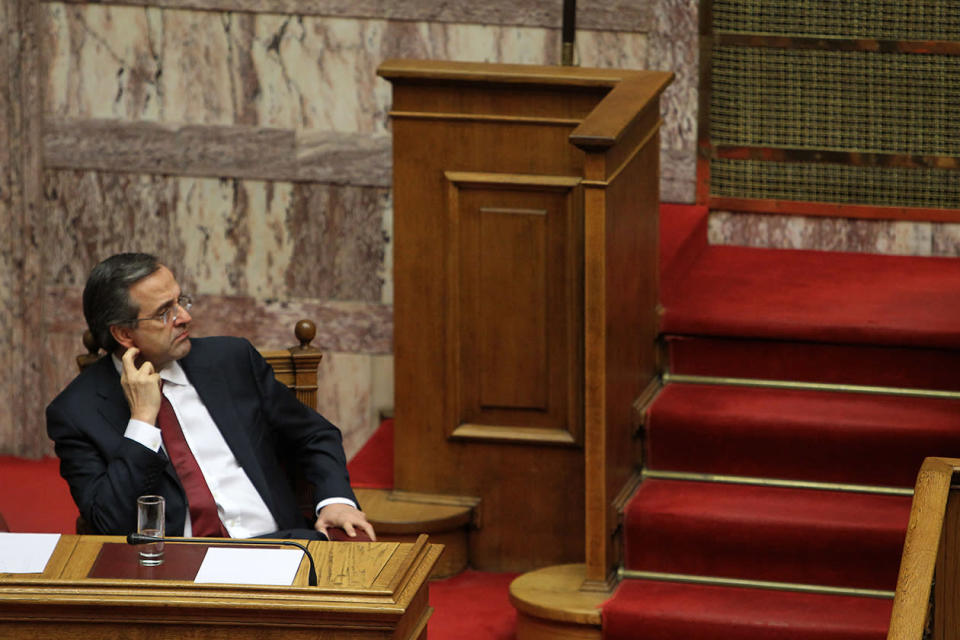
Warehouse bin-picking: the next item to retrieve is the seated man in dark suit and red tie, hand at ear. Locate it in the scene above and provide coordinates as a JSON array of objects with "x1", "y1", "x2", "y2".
[{"x1": 47, "y1": 253, "x2": 374, "y2": 538}]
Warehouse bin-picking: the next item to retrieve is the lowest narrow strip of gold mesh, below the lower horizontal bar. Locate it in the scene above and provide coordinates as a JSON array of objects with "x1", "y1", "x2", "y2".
[{"x1": 710, "y1": 158, "x2": 960, "y2": 209}]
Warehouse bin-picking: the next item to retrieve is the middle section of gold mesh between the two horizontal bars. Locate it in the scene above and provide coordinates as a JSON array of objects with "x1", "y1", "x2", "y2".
[{"x1": 710, "y1": 46, "x2": 960, "y2": 156}]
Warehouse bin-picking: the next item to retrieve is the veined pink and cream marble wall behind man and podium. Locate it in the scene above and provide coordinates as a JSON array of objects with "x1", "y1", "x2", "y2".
[{"x1": 0, "y1": 0, "x2": 698, "y2": 456}]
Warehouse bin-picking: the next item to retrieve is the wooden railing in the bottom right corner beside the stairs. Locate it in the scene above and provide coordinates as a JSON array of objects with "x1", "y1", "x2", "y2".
[{"x1": 887, "y1": 458, "x2": 960, "y2": 640}]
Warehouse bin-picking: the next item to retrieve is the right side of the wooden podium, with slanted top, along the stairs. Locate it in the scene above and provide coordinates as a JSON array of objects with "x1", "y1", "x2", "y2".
[{"x1": 570, "y1": 72, "x2": 672, "y2": 589}]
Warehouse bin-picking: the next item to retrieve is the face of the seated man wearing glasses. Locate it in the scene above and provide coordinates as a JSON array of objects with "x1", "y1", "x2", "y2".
[{"x1": 114, "y1": 266, "x2": 192, "y2": 364}]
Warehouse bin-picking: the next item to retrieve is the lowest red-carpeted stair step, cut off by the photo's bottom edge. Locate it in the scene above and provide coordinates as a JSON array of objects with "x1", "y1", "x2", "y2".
[{"x1": 603, "y1": 580, "x2": 893, "y2": 640}]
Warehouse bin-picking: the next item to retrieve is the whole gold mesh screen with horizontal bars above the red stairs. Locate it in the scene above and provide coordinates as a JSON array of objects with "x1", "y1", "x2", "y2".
[{"x1": 704, "y1": 0, "x2": 960, "y2": 210}]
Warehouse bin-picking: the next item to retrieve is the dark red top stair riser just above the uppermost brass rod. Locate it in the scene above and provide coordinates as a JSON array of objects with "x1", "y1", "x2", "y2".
[{"x1": 666, "y1": 335, "x2": 960, "y2": 391}]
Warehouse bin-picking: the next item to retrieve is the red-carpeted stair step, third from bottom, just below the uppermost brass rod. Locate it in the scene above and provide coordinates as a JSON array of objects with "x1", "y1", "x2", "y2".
[{"x1": 647, "y1": 383, "x2": 960, "y2": 487}]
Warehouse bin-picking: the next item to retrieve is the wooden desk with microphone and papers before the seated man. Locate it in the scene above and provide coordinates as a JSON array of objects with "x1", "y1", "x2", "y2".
[{"x1": 0, "y1": 536, "x2": 443, "y2": 640}]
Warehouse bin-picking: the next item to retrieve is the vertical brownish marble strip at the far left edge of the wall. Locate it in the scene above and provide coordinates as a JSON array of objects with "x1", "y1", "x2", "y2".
[{"x1": 0, "y1": 0, "x2": 47, "y2": 456}]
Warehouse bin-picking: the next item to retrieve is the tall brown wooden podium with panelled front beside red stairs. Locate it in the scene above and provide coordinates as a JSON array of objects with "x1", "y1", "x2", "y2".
[{"x1": 378, "y1": 60, "x2": 672, "y2": 580}]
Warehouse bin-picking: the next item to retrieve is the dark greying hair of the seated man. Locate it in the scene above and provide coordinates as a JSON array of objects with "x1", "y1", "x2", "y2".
[{"x1": 83, "y1": 253, "x2": 162, "y2": 353}]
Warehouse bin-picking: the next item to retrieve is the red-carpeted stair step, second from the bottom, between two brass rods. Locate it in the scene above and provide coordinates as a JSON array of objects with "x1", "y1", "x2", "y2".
[{"x1": 624, "y1": 480, "x2": 910, "y2": 590}]
